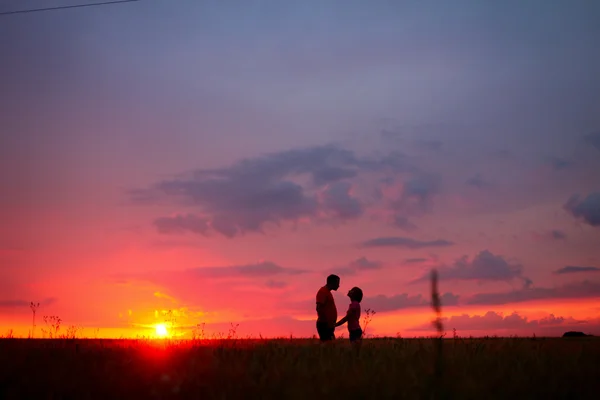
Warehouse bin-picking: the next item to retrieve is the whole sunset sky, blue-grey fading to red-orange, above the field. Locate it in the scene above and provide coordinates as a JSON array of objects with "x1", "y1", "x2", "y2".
[{"x1": 0, "y1": 0, "x2": 600, "y2": 337}]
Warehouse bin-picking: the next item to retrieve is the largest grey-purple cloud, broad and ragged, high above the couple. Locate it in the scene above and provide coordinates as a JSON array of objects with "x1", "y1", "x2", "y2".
[{"x1": 135, "y1": 146, "x2": 418, "y2": 238}]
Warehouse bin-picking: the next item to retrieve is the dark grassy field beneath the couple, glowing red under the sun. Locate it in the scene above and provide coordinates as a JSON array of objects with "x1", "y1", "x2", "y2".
[{"x1": 0, "y1": 337, "x2": 600, "y2": 400}]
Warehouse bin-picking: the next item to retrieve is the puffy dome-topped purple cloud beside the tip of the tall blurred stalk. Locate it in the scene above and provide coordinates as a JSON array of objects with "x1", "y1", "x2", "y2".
[{"x1": 413, "y1": 250, "x2": 531, "y2": 286}]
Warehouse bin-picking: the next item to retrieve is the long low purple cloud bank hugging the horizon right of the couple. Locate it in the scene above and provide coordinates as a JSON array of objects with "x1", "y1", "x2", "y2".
[{"x1": 409, "y1": 311, "x2": 598, "y2": 335}]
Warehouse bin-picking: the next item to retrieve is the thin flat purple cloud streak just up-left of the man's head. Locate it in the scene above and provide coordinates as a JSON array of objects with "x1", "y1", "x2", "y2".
[{"x1": 186, "y1": 261, "x2": 309, "y2": 278}]
